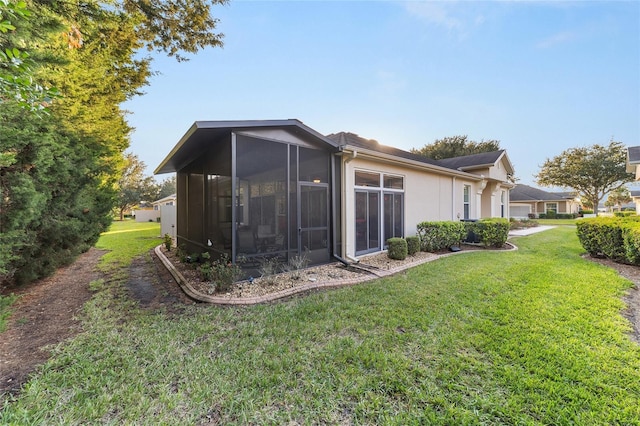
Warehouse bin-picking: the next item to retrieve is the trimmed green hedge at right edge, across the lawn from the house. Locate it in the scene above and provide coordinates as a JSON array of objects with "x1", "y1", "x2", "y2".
[{"x1": 576, "y1": 216, "x2": 640, "y2": 265}]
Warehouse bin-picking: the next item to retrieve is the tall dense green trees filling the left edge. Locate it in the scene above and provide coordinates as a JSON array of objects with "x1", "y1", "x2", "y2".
[{"x1": 0, "y1": 0, "x2": 226, "y2": 286}]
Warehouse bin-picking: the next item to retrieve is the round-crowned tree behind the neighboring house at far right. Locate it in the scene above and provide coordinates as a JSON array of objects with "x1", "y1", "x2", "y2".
[{"x1": 536, "y1": 141, "x2": 634, "y2": 215}]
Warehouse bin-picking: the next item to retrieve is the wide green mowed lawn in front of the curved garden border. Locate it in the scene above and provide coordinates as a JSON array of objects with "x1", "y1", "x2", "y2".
[{"x1": 0, "y1": 227, "x2": 640, "y2": 425}]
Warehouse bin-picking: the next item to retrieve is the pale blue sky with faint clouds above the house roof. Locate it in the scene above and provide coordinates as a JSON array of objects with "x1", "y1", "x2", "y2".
[{"x1": 124, "y1": 0, "x2": 640, "y2": 185}]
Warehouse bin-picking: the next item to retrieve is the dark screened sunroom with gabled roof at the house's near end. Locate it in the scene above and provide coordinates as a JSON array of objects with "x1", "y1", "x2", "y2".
[{"x1": 156, "y1": 120, "x2": 340, "y2": 269}]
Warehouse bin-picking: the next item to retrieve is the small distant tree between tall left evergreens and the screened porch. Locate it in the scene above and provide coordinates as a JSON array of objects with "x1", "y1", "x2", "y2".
[{"x1": 116, "y1": 154, "x2": 160, "y2": 220}]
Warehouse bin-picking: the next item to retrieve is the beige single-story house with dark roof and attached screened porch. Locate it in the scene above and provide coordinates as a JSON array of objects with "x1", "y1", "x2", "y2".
[{"x1": 155, "y1": 119, "x2": 513, "y2": 264}]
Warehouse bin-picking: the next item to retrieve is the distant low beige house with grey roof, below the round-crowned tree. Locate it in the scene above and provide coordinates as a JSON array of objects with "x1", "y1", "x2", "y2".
[{"x1": 509, "y1": 185, "x2": 580, "y2": 219}]
